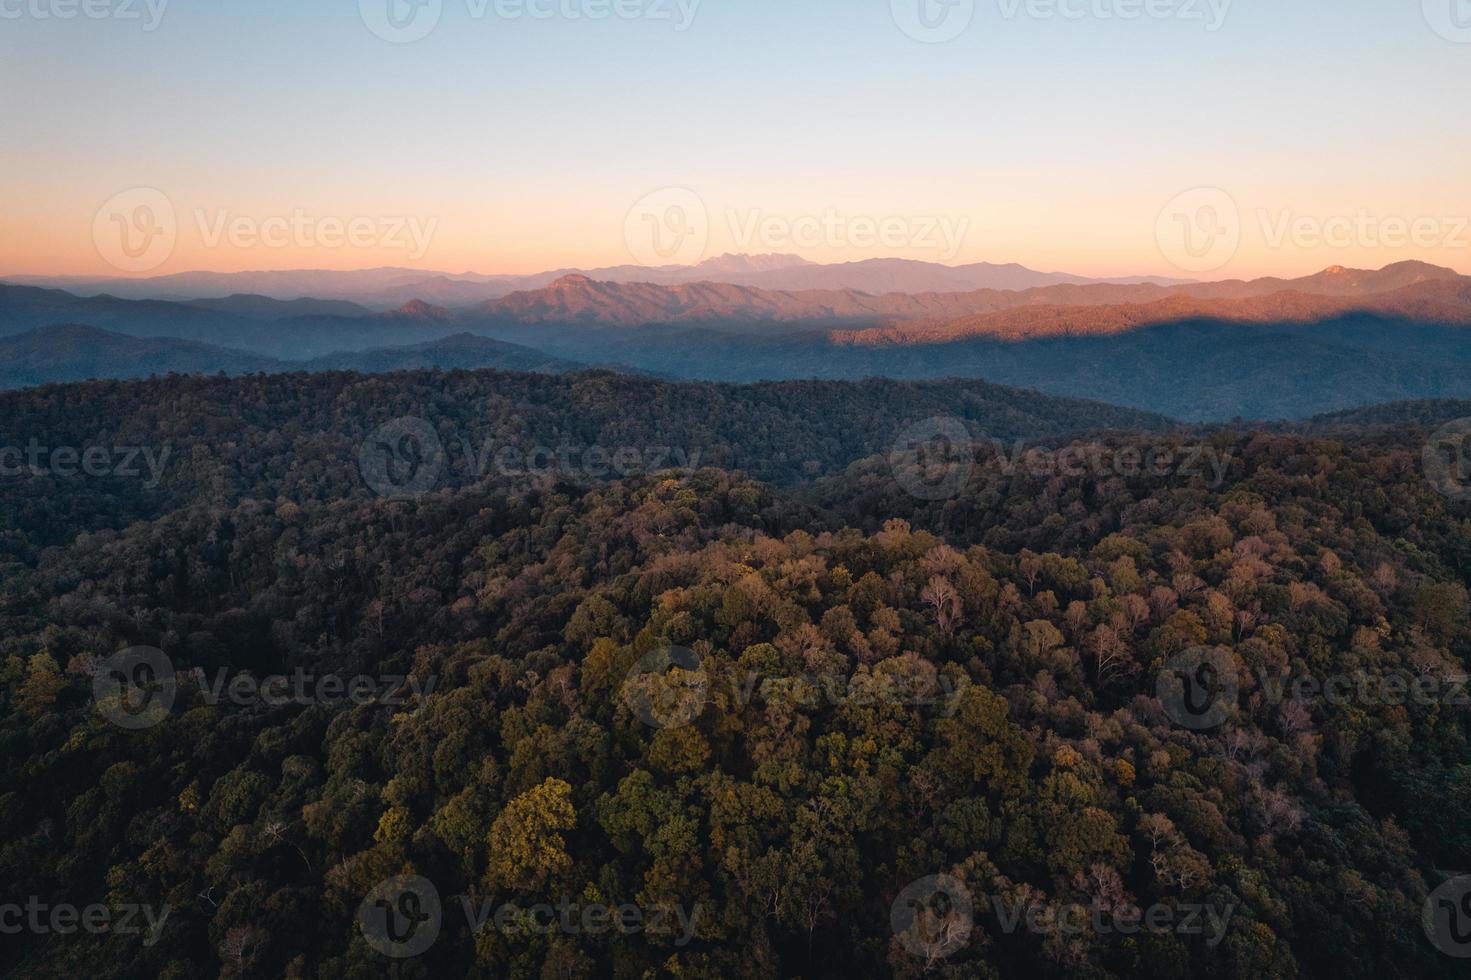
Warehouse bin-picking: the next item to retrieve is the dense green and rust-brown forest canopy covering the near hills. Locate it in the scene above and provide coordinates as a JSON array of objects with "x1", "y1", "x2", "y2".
[{"x1": 0, "y1": 364, "x2": 1471, "y2": 980}]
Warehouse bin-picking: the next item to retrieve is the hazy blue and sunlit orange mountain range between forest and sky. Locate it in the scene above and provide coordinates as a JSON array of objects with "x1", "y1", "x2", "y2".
[{"x1": 0, "y1": 258, "x2": 1471, "y2": 421}]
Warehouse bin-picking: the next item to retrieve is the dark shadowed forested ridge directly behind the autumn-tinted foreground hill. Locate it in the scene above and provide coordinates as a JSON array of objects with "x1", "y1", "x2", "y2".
[{"x1": 0, "y1": 371, "x2": 1172, "y2": 556}]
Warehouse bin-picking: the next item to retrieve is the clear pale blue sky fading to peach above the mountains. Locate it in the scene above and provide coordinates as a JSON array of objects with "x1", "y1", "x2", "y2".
[{"x1": 0, "y1": 0, "x2": 1471, "y2": 278}]
